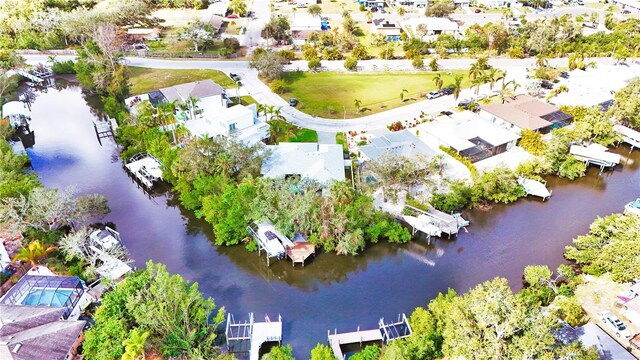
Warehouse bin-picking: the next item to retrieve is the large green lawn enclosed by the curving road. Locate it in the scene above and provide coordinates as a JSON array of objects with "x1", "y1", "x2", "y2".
[{"x1": 281, "y1": 70, "x2": 471, "y2": 120}]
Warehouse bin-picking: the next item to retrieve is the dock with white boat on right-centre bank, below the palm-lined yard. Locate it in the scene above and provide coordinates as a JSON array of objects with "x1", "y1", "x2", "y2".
[{"x1": 403, "y1": 205, "x2": 469, "y2": 237}]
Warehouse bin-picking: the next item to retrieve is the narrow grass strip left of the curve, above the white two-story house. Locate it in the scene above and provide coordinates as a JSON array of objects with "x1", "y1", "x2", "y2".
[{"x1": 127, "y1": 67, "x2": 235, "y2": 94}]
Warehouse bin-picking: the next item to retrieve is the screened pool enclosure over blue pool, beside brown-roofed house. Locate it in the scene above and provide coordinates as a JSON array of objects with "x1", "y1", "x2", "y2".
[{"x1": 0, "y1": 274, "x2": 85, "y2": 319}]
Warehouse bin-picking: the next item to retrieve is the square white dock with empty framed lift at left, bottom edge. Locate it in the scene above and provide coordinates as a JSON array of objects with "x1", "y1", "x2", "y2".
[{"x1": 225, "y1": 313, "x2": 282, "y2": 360}]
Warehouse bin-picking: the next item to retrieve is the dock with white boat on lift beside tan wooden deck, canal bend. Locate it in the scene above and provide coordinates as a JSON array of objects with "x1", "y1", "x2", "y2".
[{"x1": 247, "y1": 221, "x2": 316, "y2": 266}]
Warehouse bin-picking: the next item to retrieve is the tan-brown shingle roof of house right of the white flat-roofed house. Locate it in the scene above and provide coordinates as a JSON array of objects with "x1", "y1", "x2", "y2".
[{"x1": 481, "y1": 95, "x2": 558, "y2": 130}]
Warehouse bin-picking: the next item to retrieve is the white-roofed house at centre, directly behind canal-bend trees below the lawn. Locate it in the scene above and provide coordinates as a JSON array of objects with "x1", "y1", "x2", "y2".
[{"x1": 261, "y1": 142, "x2": 350, "y2": 184}]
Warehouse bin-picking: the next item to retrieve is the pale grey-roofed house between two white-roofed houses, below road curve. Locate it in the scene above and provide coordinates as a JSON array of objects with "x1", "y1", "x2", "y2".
[{"x1": 359, "y1": 130, "x2": 438, "y2": 162}]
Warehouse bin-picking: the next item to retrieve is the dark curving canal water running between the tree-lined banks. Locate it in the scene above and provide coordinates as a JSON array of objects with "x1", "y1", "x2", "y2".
[{"x1": 22, "y1": 81, "x2": 640, "y2": 359}]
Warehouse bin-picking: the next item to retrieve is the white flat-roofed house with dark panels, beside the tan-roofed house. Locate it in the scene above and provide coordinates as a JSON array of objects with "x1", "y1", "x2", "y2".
[{"x1": 414, "y1": 110, "x2": 520, "y2": 162}]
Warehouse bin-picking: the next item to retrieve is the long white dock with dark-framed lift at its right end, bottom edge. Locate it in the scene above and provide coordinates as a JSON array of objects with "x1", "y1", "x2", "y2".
[{"x1": 327, "y1": 314, "x2": 412, "y2": 360}]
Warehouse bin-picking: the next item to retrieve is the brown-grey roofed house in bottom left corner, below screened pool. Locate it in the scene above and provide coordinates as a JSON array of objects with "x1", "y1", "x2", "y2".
[{"x1": 0, "y1": 305, "x2": 85, "y2": 360}]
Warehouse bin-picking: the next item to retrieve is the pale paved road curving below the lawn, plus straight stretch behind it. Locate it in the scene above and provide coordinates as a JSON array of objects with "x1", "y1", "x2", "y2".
[{"x1": 25, "y1": 55, "x2": 614, "y2": 133}]
